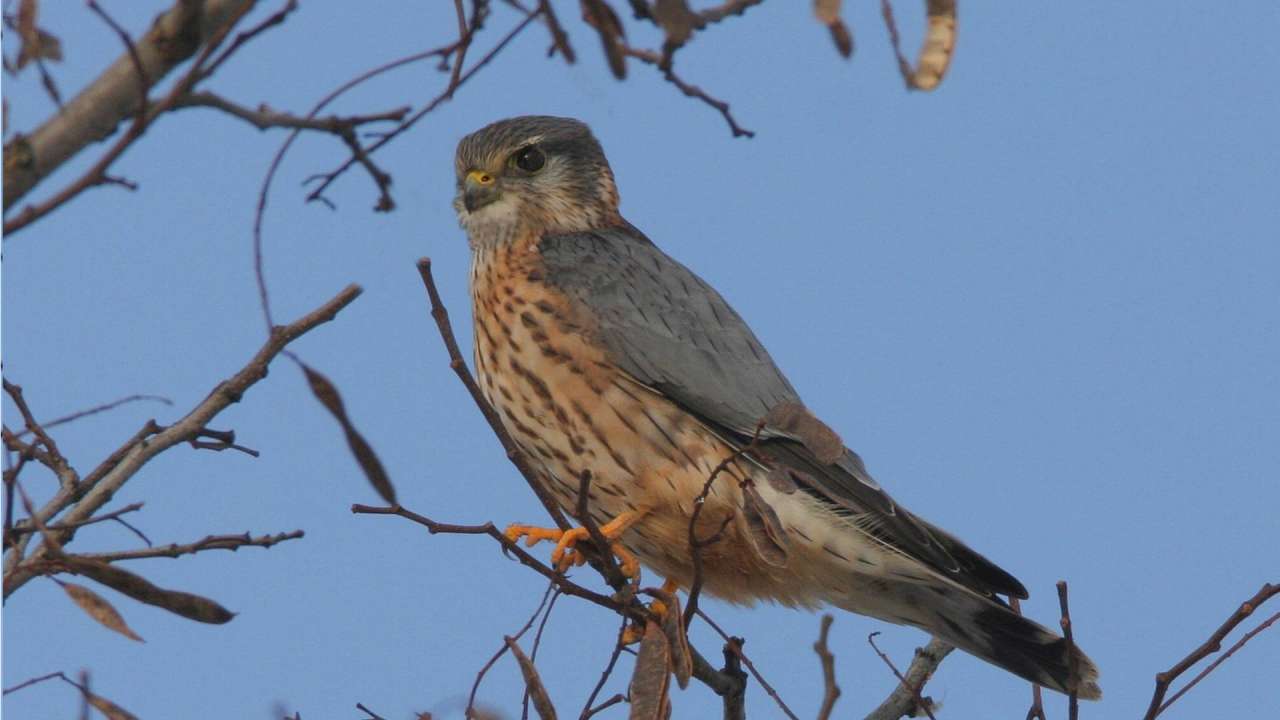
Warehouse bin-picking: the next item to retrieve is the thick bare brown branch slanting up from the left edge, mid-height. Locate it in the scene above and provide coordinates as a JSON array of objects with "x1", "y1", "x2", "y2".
[{"x1": 4, "y1": 284, "x2": 361, "y2": 597}]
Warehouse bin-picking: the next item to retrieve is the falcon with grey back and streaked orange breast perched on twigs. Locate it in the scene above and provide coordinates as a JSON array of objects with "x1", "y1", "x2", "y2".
[{"x1": 454, "y1": 117, "x2": 1101, "y2": 698}]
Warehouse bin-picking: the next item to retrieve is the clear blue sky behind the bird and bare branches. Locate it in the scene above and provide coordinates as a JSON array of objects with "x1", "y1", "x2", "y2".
[{"x1": 3, "y1": 1, "x2": 1280, "y2": 719}]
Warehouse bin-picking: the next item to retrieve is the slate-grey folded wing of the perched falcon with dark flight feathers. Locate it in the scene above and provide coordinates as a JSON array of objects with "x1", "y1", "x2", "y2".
[{"x1": 539, "y1": 225, "x2": 1027, "y2": 597}]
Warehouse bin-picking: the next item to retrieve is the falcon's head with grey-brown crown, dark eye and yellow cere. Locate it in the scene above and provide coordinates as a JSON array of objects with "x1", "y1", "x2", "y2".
[{"x1": 453, "y1": 115, "x2": 621, "y2": 241}]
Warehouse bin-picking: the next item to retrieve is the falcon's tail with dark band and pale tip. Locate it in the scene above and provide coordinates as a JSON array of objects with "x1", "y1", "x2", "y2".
[{"x1": 837, "y1": 579, "x2": 1102, "y2": 700}]
